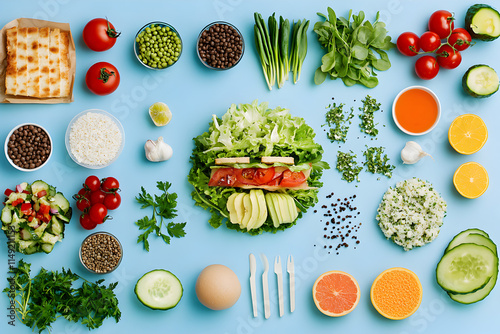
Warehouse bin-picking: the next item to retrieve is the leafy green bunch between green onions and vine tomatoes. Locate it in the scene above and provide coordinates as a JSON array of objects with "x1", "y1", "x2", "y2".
[{"x1": 314, "y1": 7, "x2": 395, "y2": 88}]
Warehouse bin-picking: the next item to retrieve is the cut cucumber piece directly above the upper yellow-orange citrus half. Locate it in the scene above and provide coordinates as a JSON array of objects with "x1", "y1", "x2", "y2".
[{"x1": 462, "y1": 64, "x2": 500, "y2": 98}]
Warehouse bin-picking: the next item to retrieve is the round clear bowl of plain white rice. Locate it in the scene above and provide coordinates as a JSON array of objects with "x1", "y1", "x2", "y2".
[{"x1": 66, "y1": 109, "x2": 125, "y2": 169}]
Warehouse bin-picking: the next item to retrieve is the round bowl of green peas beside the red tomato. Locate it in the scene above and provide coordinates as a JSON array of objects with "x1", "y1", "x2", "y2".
[{"x1": 134, "y1": 21, "x2": 182, "y2": 70}]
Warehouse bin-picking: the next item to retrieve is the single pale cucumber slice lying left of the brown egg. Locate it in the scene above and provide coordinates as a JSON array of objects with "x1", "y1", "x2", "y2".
[{"x1": 134, "y1": 269, "x2": 183, "y2": 310}]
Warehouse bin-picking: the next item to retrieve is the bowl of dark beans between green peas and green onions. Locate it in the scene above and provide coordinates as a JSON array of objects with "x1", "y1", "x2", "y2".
[{"x1": 196, "y1": 21, "x2": 245, "y2": 70}]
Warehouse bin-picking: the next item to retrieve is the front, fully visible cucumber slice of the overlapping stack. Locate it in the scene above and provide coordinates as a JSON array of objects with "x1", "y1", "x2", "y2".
[{"x1": 436, "y1": 243, "x2": 498, "y2": 293}]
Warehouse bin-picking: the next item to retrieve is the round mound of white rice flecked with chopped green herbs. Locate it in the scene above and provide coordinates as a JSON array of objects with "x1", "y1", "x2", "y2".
[{"x1": 377, "y1": 178, "x2": 446, "y2": 251}]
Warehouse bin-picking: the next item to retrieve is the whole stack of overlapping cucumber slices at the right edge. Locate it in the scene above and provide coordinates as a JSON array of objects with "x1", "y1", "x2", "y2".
[{"x1": 436, "y1": 229, "x2": 498, "y2": 304}]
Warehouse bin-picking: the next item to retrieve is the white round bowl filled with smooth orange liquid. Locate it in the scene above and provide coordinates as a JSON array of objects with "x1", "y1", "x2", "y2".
[{"x1": 392, "y1": 86, "x2": 441, "y2": 136}]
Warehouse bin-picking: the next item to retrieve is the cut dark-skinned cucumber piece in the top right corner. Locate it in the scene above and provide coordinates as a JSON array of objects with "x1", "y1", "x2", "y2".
[{"x1": 465, "y1": 4, "x2": 500, "y2": 42}]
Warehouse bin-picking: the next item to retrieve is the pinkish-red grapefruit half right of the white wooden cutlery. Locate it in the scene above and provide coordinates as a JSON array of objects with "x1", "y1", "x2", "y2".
[{"x1": 313, "y1": 270, "x2": 360, "y2": 317}]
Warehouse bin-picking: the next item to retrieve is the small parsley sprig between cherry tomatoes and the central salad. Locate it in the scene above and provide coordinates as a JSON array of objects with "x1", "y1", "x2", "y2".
[{"x1": 135, "y1": 181, "x2": 186, "y2": 252}]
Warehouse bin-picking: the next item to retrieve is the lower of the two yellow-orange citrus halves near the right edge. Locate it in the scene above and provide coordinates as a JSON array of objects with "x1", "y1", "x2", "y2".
[{"x1": 453, "y1": 161, "x2": 489, "y2": 198}]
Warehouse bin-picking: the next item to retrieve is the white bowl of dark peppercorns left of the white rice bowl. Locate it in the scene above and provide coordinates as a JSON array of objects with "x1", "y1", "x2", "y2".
[{"x1": 4, "y1": 123, "x2": 52, "y2": 172}]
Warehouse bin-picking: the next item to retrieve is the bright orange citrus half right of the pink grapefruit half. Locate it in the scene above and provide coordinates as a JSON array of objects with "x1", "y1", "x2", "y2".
[{"x1": 370, "y1": 268, "x2": 423, "y2": 320}]
